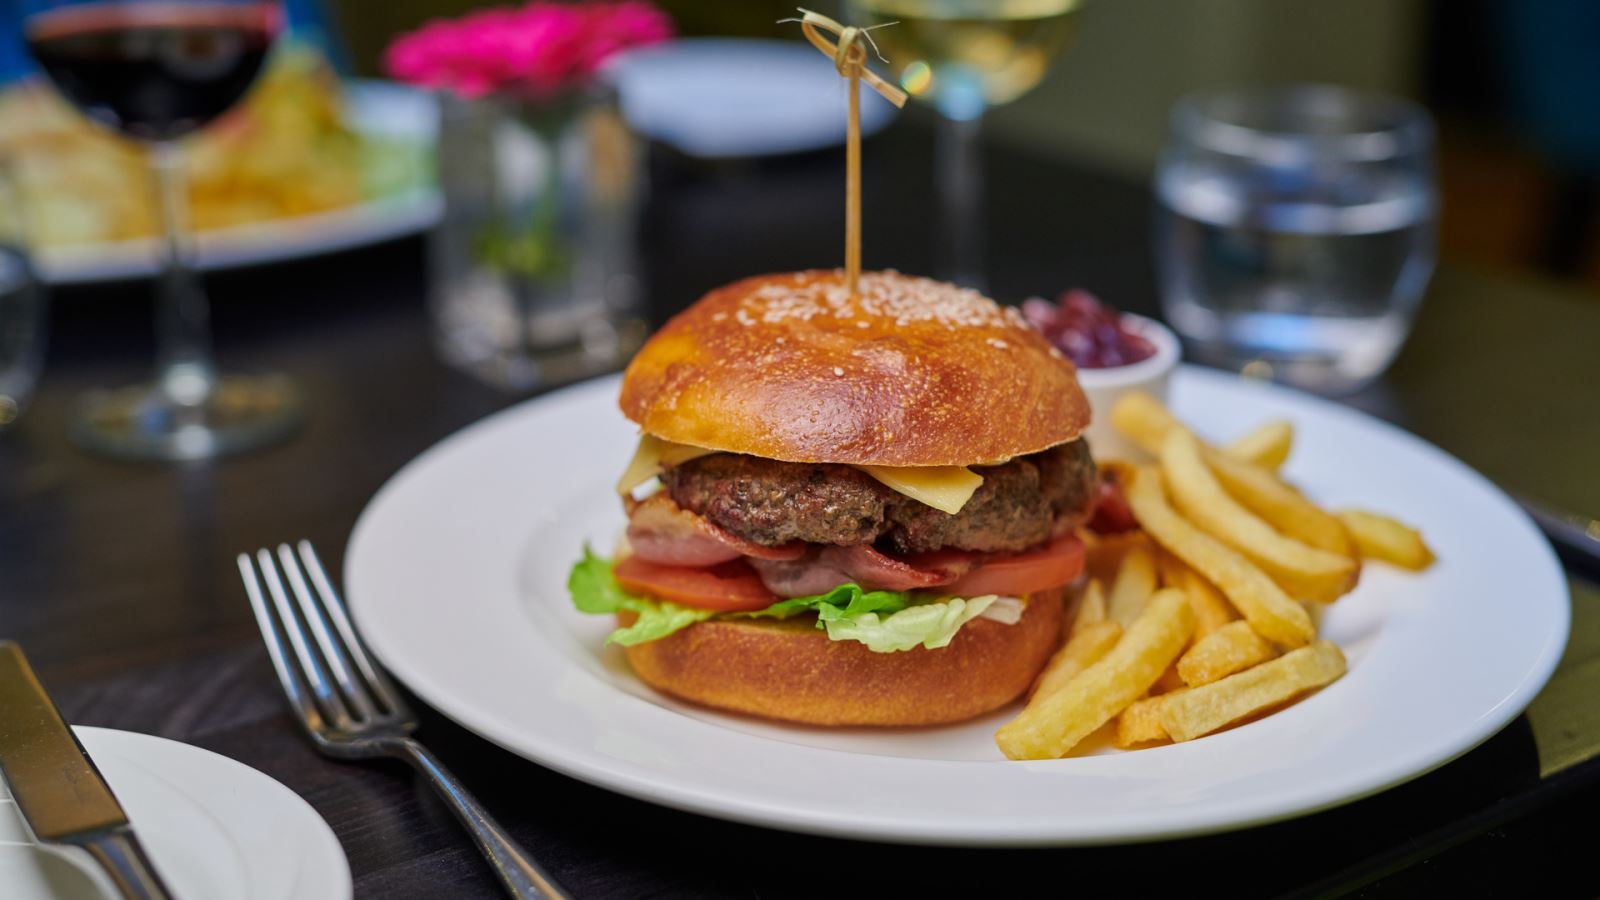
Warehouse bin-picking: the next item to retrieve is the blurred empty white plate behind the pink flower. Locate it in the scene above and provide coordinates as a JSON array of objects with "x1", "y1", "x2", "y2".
[{"x1": 610, "y1": 38, "x2": 894, "y2": 159}]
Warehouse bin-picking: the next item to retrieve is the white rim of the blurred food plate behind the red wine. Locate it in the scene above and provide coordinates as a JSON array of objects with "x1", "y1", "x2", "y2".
[{"x1": 37, "y1": 80, "x2": 443, "y2": 285}]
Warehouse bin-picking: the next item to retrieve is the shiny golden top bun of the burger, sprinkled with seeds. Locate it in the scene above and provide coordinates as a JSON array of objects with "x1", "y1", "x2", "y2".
[{"x1": 621, "y1": 271, "x2": 1090, "y2": 466}]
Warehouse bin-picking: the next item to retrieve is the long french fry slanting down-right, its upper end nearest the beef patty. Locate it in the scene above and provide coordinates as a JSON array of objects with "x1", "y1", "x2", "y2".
[{"x1": 1126, "y1": 463, "x2": 1315, "y2": 647}]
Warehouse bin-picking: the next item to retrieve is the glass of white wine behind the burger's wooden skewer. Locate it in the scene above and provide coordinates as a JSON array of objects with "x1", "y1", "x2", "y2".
[{"x1": 851, "y1": 0, "x2": 1083, "y2": 290}]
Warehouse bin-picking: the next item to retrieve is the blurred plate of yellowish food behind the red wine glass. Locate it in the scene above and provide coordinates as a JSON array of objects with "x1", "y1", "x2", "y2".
[{"x1": 0, "y1": 46, "x2": 440, "y2": 283}]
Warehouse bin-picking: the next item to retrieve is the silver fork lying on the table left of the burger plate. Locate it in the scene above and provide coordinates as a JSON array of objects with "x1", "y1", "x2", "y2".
[{"x1": 238, "y1": 541, "x2": 568, "y2": 898}]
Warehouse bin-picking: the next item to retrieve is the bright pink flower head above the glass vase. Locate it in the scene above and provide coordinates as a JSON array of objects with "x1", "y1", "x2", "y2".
[{"x1": 384, "y1": 0, "x2": 672, "y2": 98}]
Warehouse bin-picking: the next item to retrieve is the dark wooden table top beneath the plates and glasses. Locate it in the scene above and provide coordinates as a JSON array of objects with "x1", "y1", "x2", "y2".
[{"x1": 0, "y1": 125, "x2": 1600, "y2": 898}]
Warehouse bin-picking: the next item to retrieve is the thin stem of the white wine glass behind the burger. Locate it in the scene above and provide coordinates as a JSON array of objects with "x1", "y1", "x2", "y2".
[{"x1": 934, "y1": 115, "x2": 987, "y2": 290}]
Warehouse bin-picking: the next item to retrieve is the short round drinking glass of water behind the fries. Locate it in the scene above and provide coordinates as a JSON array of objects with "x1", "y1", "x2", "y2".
[{"x1": 1155, "y1": 86, "x2": 1438, "y2": 394}]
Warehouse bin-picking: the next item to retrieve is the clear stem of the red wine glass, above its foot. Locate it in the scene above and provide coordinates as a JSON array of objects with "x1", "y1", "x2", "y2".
[{"x1": 147, "y1": 141, "x2": 216, "y2": 407}]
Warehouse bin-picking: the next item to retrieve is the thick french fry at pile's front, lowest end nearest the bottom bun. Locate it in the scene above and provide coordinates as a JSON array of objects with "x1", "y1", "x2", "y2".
[{"x1": 995, "y1": 591, "x2": 1194, "y2": 759}]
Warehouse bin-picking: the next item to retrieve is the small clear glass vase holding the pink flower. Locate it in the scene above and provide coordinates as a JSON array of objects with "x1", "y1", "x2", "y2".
[{"x1": 430, "y1": 86, "x2": 645, "y2": 391}]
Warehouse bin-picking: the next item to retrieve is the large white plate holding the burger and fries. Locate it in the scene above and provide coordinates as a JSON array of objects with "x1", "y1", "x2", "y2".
[{"x1": 346, "y1": 361, "x2": 1570, "y2": 844}]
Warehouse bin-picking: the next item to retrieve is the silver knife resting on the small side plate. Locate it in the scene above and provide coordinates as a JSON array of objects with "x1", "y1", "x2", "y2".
[{"x1": 0, "y1": 641, "x2": 171, "y2": 900}]
